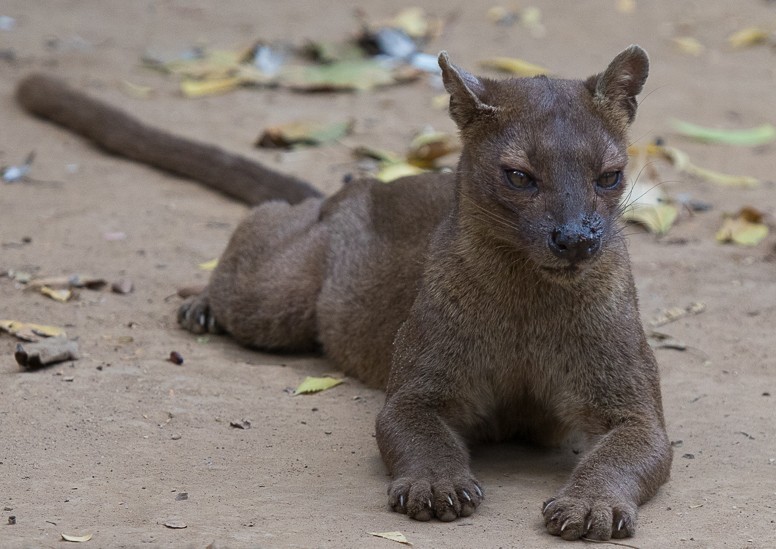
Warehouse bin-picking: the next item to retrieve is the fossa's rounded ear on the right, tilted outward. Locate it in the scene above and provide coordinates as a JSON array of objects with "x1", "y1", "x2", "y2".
[{"x1": 585, "y1": 45, "x2": 649, "y2": 124}]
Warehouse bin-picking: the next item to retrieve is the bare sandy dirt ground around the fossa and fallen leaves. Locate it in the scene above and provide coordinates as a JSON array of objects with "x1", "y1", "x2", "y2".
[{"x1": 0, "y1": 0, "x2": 776, "y2": 549}]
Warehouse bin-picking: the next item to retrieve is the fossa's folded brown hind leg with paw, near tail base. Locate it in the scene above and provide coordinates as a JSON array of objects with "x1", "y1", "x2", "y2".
[{"x1": 178, "y1": 199, "x2": 328, "y2": 351}]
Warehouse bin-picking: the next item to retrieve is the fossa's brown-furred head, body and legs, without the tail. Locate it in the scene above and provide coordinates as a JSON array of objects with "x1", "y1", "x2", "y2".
[{"x1": 18, "y1": 46, "x2": 671, "y2": 539}]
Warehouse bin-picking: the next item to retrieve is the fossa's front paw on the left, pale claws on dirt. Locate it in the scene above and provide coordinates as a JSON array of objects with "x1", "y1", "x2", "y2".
[{"x1": 388, "y1": 477, "x2": 484, "y2": 522}]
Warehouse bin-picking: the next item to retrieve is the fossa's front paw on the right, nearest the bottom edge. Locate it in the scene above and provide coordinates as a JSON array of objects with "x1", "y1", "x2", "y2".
[{"x1": 542, "y1": 495, "x2": 637, "y2": 540}]
